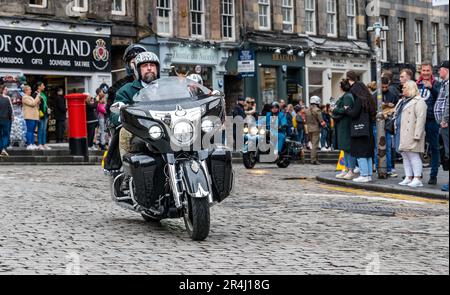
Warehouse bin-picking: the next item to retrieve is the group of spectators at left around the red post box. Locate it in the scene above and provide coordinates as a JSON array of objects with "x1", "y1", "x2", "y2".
[{"x1": 0, "y1": 78, "x2": 109, "y2": 157}]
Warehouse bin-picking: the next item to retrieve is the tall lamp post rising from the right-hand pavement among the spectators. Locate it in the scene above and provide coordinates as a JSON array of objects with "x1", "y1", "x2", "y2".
[{"x1": 367, "y1": 22, "x2": 390, "y2": 179}]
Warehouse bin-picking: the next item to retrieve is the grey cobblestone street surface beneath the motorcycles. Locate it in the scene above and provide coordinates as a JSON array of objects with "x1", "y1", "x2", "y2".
[{"x1": 0, "y1": 164, "x2": 449, "y2": 275}]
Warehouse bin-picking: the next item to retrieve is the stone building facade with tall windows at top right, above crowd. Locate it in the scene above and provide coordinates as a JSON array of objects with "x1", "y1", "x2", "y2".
[{"x1": 369, "y1": 0, "x2": 449, "y2": 75}]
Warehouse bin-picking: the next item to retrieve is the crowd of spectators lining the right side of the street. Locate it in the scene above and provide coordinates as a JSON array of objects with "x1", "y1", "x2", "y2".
[{"x1": 233, "y1": 61, "x2": 449, "y2": 191}]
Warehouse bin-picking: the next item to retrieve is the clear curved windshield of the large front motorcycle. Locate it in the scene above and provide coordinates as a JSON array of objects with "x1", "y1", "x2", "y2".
[{"x1": 135, "y1": 77, "x2": 211, "y2": 103}]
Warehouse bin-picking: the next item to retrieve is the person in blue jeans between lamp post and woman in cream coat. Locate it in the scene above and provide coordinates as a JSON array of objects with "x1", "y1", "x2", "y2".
[{"x1": 381, "y1": 77, "x2": 400, "y2": 178}]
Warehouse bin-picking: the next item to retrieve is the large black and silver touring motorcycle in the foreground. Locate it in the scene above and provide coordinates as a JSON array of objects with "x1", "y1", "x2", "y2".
[{"x1": 105, "y1": 77, "x2": 234, "y2": 241}]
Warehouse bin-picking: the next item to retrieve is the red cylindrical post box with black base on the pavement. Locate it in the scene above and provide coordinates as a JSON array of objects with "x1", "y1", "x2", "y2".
[{"x1": 65, "y1": 93, "x2": 88, "y2": 157}]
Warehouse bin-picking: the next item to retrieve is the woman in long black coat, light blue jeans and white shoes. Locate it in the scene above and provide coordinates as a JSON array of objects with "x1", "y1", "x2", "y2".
[{"x1": 345, "y1": 71, "x2": 377, "y2": 183}]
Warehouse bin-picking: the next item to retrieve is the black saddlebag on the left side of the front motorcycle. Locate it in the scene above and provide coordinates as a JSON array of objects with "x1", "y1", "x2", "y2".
[{"x1": 123, "y1": 154, "x2": 165, "y2": 209}]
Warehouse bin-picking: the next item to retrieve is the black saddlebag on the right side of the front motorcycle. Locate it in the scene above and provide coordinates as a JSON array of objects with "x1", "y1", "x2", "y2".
[{"x1": 208, "y1": 149, "x2": 234, "y2": 203}]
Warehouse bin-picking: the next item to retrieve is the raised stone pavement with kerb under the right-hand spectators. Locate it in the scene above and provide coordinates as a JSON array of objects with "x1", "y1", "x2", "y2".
[{"x1": 317, "y1": 165, "x2": 449, "y2": 200}]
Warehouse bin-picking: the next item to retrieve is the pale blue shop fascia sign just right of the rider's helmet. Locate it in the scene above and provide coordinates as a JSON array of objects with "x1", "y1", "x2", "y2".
[{"x1": 172, "y1": 47, "x2": 218, "y2": 65}]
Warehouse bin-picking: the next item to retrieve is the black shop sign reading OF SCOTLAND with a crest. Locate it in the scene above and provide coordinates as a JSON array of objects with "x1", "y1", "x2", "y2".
[{"x1": 0, "y1": 29, "x2": 111, "y2": 72}]
